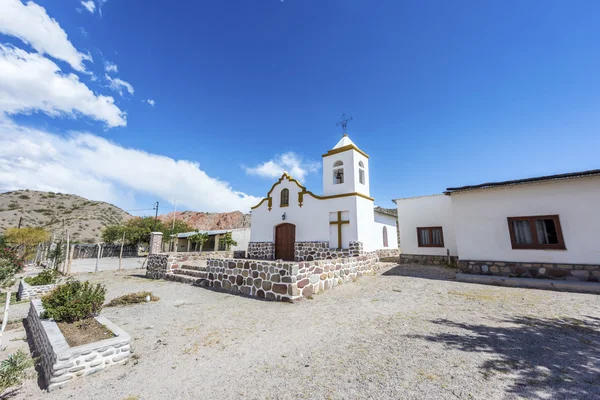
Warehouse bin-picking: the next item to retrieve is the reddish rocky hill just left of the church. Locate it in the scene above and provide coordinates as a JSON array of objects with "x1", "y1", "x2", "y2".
[{"x1": 158, "y1": 211, "x2": 250, "y2": 231}]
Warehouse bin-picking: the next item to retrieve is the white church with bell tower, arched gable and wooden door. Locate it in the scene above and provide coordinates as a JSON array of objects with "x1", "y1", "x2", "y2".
[{"x1": 248, "y1": 134, "x2": 398, "y2": 261}]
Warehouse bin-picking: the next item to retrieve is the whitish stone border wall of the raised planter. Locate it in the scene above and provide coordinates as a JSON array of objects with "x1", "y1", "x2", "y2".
[{"x1": 27, "y1": 300, "x2": 131, "y2": 391}]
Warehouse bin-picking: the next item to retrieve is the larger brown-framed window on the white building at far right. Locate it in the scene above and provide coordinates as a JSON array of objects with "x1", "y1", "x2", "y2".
[{"x1": 508, "y1": 215, "x2": 566, "y2": 250}]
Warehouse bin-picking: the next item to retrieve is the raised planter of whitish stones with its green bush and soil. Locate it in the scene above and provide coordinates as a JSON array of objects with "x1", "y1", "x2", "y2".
[{"x1": 27, "y1": 280, "x2": 131, "y2": 391}]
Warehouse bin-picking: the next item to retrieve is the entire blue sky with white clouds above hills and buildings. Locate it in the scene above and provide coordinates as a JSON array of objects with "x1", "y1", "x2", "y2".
[{"x1": 0, "y1": 0, "x2": 600, "y2": 217}]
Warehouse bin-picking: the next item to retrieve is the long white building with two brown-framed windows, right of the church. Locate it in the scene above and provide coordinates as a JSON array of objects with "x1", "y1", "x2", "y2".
[{"x1": 396, "y1": 170, "x2": 600, "y2": 280}]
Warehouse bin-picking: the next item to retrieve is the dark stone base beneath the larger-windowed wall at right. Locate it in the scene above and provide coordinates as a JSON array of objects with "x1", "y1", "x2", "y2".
[{"x1": 458, "y1": 260, "x2": 600, "y2": 282}]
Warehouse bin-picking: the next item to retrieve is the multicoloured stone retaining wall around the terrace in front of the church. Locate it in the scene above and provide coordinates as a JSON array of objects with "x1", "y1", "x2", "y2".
[{"x1": 195, "y1": 253, "x2": 380, "y2": 301}]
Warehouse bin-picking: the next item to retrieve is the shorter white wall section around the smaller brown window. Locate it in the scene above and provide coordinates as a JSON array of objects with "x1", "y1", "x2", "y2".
[{"x1": 396, "y1": 194, "x2": 458, "y2": 256}]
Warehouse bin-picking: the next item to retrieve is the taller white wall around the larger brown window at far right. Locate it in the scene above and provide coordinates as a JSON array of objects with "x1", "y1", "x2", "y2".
[{"x1": 452, "y1": 177, "x2": 600, "y2": 264}]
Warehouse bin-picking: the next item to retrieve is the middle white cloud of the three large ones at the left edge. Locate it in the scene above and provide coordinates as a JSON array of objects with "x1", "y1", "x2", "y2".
[{"x1": 0, "y1": 44, "x2": 127, "y2": 127}]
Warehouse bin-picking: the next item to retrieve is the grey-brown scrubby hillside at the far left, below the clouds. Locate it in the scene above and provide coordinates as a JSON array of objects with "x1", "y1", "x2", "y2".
[{"x1": 0, "y1": 190, "x2": 131, "y2": 243}]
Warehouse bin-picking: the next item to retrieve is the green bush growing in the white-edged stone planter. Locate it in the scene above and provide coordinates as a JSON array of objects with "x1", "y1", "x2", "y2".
[{"x1": 42, "y1": 280, "x2": 106, "y2": 322}]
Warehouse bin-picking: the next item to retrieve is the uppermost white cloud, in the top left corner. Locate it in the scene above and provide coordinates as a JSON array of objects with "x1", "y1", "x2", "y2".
[{"x1": 0, "y1": 0, "x2": 92, "y2": 72}]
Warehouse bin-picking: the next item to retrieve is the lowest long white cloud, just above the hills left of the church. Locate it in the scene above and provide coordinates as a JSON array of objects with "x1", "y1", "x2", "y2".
[{"x1": 0, "y1": 119, "x2": 260, "y2": 212}]
